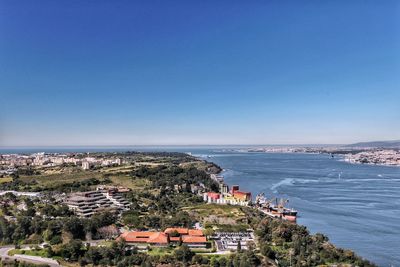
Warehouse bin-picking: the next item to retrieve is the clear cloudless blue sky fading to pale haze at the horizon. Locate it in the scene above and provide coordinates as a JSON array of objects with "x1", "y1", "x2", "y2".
[{"x1": 0, "y1": 0, "x2": 400, "y2": 146}]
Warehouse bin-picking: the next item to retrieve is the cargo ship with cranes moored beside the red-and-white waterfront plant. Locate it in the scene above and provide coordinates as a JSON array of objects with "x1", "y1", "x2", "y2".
[{"x1": 255, "y1": 194, "x2": 297, "y2": 222}]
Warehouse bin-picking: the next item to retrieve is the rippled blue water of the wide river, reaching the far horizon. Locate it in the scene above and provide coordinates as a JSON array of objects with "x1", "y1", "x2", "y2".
[{"x1": 0, "y1": 147, "x2": 400, "y2": 266}]
